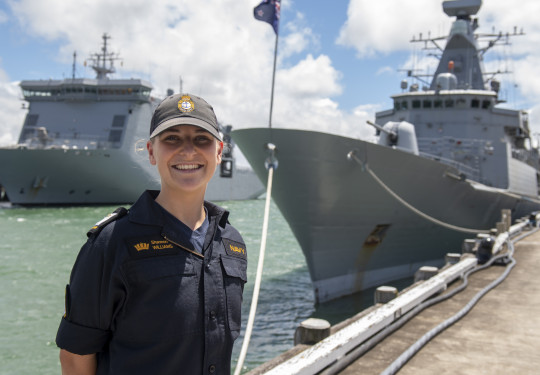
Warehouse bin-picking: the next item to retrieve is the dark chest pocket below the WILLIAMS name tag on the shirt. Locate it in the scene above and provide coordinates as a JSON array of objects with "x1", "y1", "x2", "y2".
[{"x1": 121, "y1": 255, "x2": 204, "y2": 345}]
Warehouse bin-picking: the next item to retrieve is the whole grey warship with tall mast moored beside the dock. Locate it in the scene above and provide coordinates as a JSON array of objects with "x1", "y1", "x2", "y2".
[{"x1": 232, "y1": 0, "x2": 540, "y2": 302}]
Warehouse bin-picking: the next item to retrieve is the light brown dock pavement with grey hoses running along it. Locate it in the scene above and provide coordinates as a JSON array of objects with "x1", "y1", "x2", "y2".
[{"x1": 340, "y1": 231, "x2": 540, "y2": 375}]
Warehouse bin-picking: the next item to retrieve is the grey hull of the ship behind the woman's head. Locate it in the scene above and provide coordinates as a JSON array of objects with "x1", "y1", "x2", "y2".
[{"x1": 0, "y1": 148, "x2": 264, "y2": 206}]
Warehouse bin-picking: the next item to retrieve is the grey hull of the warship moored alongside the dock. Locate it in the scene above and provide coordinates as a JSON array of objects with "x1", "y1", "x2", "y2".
[{"x1": 233, "y1": 128, "x2": 540, "y2": 302}]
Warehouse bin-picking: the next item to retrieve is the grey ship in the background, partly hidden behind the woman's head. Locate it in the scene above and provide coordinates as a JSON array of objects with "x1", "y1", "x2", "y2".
[{"x1": 0, "y1": 34, "x2": 264, "y2": 206}]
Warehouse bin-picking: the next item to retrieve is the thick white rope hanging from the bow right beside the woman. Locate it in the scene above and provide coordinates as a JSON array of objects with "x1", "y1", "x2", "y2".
[{"x1": 234, "y1": 166, "x2": 274, "y2": 375}]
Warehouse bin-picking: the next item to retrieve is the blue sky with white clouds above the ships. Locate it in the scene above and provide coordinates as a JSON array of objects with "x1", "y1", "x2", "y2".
[{"x1": 0, "y1": 0, "x2": 540, "y2": 154}]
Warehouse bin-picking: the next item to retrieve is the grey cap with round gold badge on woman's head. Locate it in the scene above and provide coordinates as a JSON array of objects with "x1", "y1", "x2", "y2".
[{"x1": 150, "y1": 94, "x2": 222, "y2": 141}]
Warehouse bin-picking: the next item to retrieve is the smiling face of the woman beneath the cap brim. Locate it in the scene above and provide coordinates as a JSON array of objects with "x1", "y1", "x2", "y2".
[{"x1": 147, "y1": 125, "x2": 223, "y2": 195}]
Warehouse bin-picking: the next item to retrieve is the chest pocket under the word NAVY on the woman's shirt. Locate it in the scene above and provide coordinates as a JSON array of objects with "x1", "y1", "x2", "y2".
[{"x1": 221, "y1": 255, "x2": 247, "y2": 340}]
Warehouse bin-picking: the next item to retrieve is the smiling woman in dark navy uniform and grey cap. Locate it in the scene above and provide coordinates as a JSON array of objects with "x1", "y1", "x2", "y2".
[{"x1": 56, "y1": 95, "x2": 247, "y2": 375}]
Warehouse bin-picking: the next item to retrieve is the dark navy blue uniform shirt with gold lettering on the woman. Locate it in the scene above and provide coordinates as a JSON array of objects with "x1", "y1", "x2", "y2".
[{"x1": 56, "y1": 192, "x2": 247, "y2": 375}]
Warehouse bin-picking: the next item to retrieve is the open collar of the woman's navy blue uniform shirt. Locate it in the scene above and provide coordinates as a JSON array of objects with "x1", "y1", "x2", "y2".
[{"x1": 129, "y1": 190, "x2": 229, "y2": 228}]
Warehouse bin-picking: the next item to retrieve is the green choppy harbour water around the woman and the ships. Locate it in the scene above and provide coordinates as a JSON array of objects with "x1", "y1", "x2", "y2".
[{"x1": 0, "y1": 200, "x2": 396, "y2": 375}]
